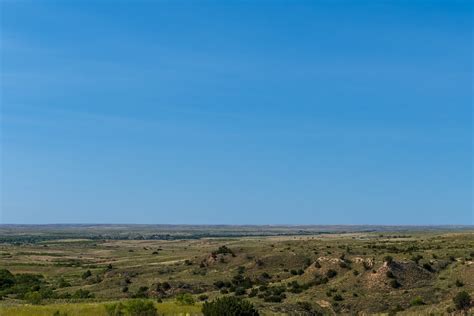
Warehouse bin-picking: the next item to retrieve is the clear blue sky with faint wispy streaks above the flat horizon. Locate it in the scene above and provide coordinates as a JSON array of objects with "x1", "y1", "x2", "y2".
[{"x1": 0, "y1": 0, "x2": 473, "y2": 224}]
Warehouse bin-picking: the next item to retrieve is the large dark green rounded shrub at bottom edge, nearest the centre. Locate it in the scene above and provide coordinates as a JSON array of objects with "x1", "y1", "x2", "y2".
[{"x1": 202, "y1": 296, "x2": 259, "y2": 316}]
